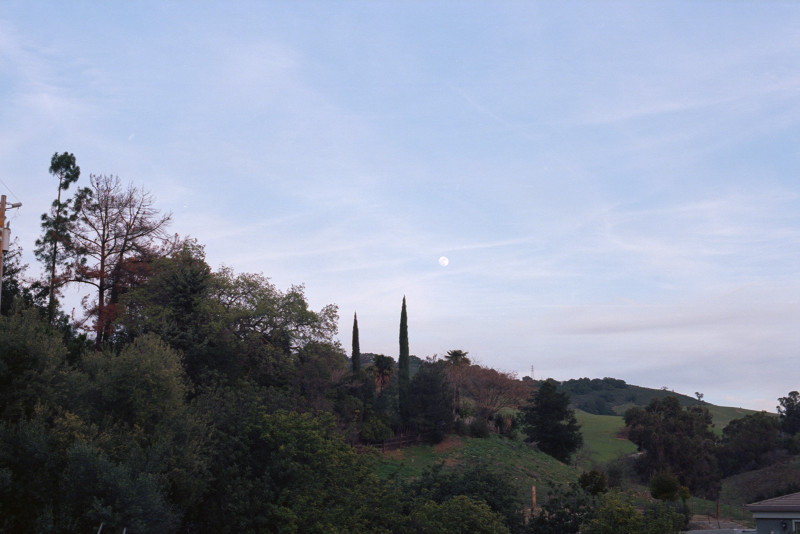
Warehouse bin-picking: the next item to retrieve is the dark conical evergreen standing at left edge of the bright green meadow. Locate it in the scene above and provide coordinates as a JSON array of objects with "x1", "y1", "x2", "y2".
[{"x1": 522, "y1": 378, "x2": 583, "y2": 462}]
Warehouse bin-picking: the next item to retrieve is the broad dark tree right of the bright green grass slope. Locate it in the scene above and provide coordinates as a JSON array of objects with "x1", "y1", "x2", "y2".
[{"x1": 625, "y1": 395, "x2": 720, "y2": 498}]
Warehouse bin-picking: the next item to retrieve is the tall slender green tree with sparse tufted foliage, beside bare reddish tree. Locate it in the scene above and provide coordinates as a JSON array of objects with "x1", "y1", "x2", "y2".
[{"x1": 34, "y1": 152, "x2": 86, "y2": 323}]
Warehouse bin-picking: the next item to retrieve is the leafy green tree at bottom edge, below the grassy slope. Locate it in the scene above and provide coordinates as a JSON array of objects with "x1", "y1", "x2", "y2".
[{"x1": 250, "y1": 411, "x2": 392, "y2": 532}]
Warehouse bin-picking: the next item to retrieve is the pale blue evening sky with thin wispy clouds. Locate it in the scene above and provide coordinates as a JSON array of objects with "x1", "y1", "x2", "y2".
[{"x1": 0, "y1": 0, "x2": 800, "y2": 412}]
